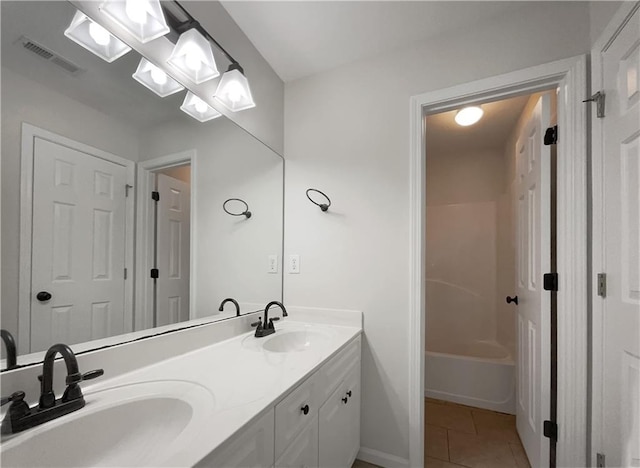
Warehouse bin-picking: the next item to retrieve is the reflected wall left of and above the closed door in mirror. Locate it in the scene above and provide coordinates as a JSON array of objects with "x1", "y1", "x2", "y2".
[{"x1": 1, "y1": 67, "x2": 138, "y2": 337}]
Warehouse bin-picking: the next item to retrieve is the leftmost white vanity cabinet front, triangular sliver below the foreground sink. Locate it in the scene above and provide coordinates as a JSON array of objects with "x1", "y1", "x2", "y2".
[{"x1": 196, "y1": 410, "x2": 274, "y2": 468}]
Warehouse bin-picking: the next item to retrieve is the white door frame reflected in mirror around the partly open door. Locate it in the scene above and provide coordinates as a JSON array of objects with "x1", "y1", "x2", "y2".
[{"x1": 134, "y1": 149, "x2": 198, "y2": 331}]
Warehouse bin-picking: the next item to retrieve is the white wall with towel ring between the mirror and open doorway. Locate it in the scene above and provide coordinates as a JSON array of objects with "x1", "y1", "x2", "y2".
[{"x1": 285, "y1": 2, "x2": 590, "y2": 465}]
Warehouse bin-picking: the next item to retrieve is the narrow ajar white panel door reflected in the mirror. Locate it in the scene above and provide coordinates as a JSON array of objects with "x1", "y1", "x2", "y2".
[{"x1": 156, "y1": 174, "x2": 191, "y2": 326}]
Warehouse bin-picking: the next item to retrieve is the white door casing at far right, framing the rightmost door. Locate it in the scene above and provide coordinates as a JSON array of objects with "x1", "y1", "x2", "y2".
[{"x1": 587, "y1": 2, "x2": 640, "y2": 466}]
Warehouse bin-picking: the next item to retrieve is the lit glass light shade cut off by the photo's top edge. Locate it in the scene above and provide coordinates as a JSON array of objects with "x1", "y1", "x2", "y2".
[{"x1": 100, "y1": 0, "x2": 169, "y2": 43}]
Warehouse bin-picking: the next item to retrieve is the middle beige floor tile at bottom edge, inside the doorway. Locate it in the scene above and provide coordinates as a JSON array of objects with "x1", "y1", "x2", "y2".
[{"x1": 449, "y1": 430, "x2": 517, "y2": 468}]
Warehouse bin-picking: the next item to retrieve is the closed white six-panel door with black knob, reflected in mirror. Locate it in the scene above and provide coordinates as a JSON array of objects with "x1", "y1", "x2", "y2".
[{"x1": 31, "y1": 138, "x2": 127, "y2": 352}]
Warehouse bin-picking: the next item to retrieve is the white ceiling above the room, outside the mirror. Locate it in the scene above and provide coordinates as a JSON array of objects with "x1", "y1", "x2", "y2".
[{"x1": 222, "y1": 0, "x2": 533, "y2": 82}]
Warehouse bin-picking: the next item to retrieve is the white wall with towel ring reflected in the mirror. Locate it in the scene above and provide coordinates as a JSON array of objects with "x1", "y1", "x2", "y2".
[{"x1": 140, "y1": 118, "x2": 284, "y2": 317}]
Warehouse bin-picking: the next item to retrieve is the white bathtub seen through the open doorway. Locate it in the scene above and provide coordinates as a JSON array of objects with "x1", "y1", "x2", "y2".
[{"x1": 425, "y1": 341, "x2": 516, "y2": 414}]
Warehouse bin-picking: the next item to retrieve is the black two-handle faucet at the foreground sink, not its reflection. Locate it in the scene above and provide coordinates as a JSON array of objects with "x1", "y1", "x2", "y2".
[{"x1": 2, "y1": 343, "x2": 104, "y2": 434}]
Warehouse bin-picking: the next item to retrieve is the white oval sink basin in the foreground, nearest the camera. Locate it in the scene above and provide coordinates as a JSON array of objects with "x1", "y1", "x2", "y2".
[{"x1": 0, "y1": 381, "x2": 214, "y2": 467}]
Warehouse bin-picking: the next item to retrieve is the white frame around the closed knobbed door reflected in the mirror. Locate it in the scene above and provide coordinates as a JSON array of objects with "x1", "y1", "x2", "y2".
[{"x1": 18, "y1": 122, "x2": 135, "y2": 354}]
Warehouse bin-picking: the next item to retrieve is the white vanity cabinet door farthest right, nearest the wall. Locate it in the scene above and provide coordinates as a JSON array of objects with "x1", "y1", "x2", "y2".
[{"x1": 318, "y1": 365, "x2": 360, "y2": 468}]
